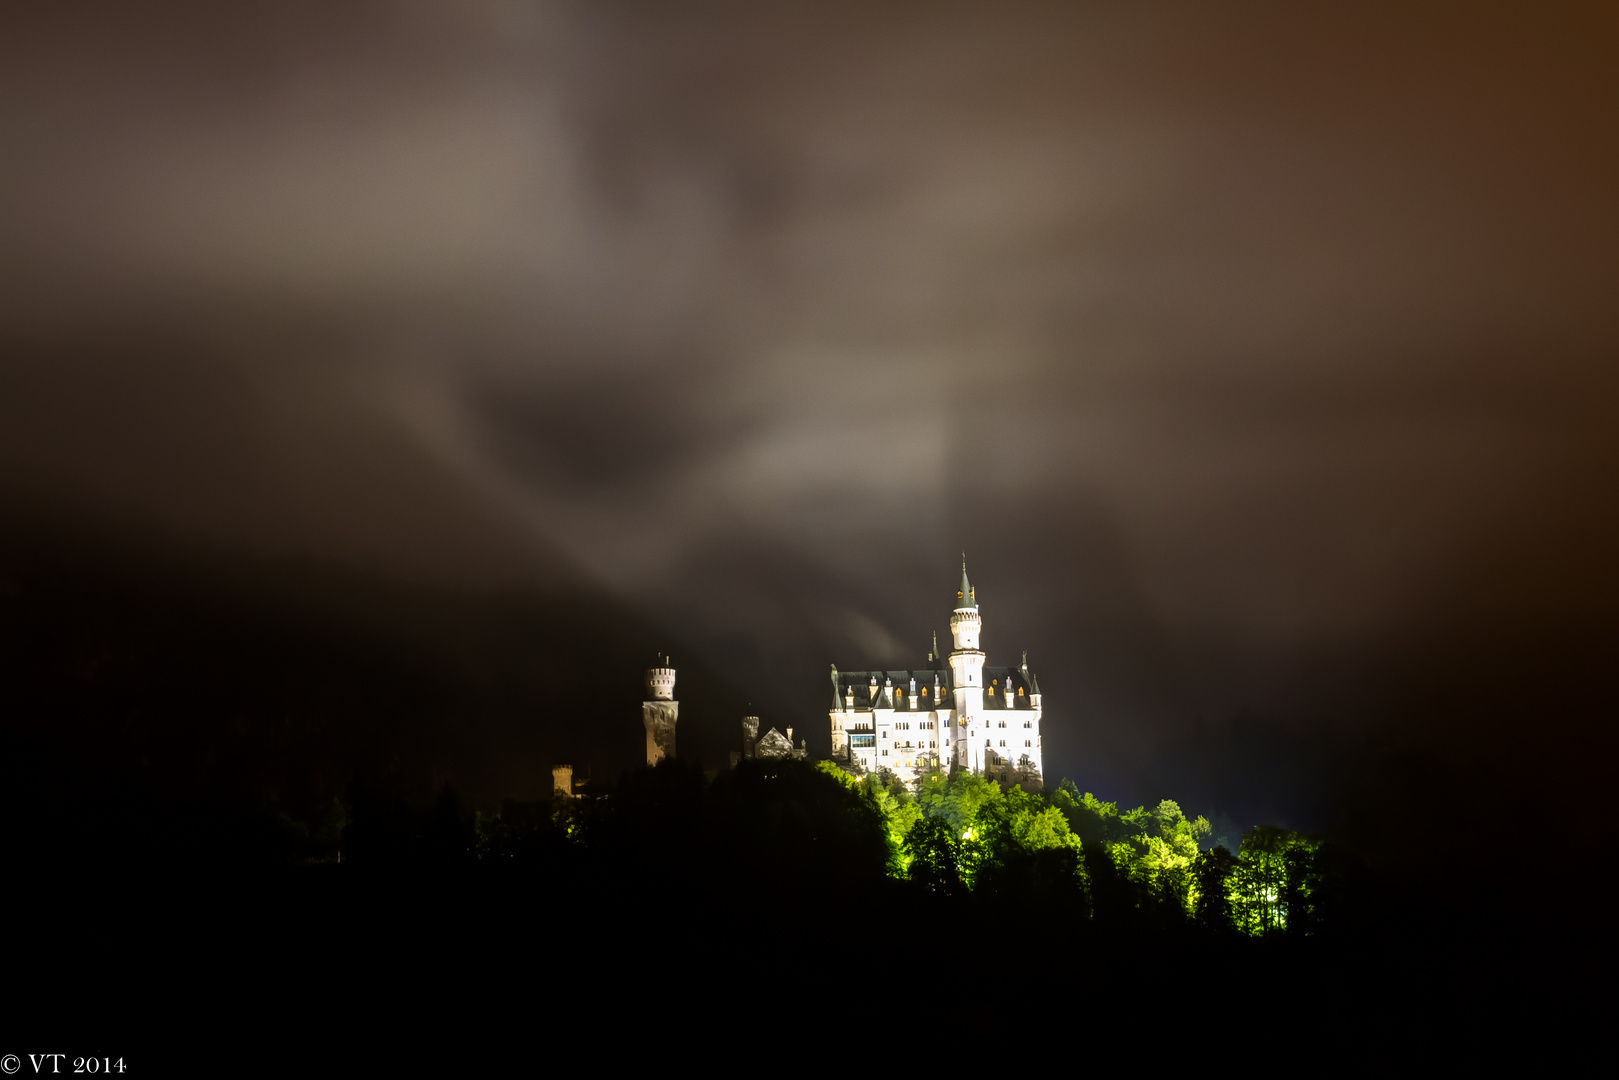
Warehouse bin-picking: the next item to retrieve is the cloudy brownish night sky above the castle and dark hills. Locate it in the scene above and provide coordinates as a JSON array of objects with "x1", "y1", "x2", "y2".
[{"x1": 0, "y1": 2, "x2": 1619, "y2": 827}]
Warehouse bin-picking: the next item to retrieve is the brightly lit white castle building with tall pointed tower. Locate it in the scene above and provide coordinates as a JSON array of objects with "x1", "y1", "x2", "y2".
[{"x1": 831, "y1": 559, "x2": 1043, "y2": 790}]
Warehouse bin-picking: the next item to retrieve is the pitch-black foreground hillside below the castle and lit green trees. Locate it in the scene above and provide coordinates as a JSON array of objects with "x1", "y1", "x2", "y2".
[{"x1": 8, "y1": 764, "x2": 1604, "y2": 1075}]
